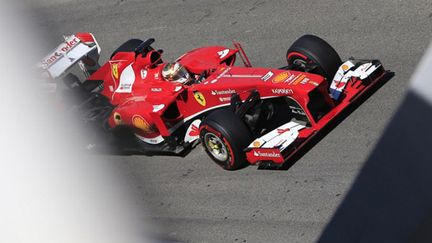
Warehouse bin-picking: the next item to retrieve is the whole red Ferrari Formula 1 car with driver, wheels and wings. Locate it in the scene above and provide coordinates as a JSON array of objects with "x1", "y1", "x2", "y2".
[{"x1": 39, "y1": 33, "x2": 389, "y2": 170}]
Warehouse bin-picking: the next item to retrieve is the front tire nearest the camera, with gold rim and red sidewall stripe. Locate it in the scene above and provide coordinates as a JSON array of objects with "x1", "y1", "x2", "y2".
[{"x1": 200, "y1": 109, "x2": 253, "y2": 170}]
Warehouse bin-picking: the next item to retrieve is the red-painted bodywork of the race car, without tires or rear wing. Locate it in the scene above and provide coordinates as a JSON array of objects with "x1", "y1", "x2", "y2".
[{"x1": 82, "y1": 37, "x2": 385, "y2": 164}]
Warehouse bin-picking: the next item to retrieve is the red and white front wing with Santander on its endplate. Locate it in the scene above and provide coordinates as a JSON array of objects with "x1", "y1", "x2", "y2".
[{"x1": 245, "y1": 60, "x2": 392, "y2": 166}]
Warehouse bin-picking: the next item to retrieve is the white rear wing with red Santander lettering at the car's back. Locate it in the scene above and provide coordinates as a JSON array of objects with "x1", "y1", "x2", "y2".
[{"x1": 37, "y1": 33, "x2": 101, "y2": 79}]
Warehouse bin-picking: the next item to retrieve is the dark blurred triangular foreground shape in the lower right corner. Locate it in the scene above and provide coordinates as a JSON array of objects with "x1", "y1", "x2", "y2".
[{"x1": 318, "y1": 91, "x2": 432, "y2": 243}]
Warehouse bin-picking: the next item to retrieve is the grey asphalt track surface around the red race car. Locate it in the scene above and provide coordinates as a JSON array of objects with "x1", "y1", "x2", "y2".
[{"x1": 28, "y1": 0, "x2": 432, "y2": 242}]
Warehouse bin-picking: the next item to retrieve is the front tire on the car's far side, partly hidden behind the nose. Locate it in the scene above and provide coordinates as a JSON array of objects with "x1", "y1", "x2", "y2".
[{"x1": 287, "y1": 35, "x2": 342, "y2": 83}]
